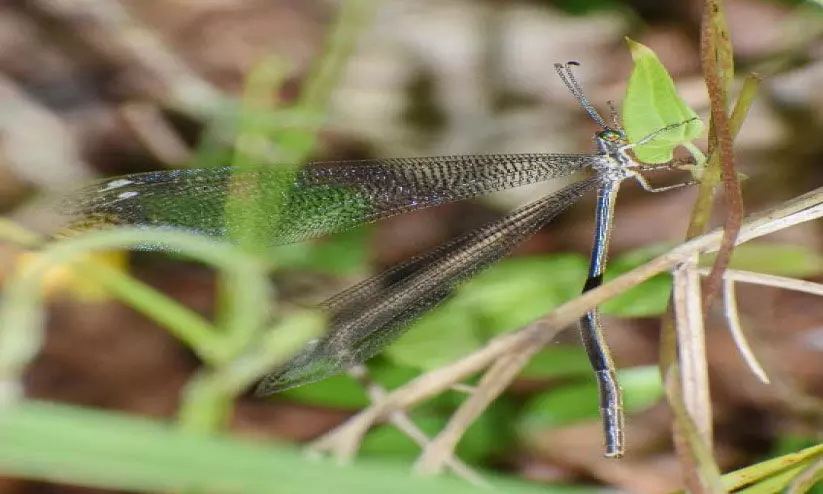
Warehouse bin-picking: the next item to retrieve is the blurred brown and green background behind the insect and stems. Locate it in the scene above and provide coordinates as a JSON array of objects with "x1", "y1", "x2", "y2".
[{"x1": 0, "y1": 0, "x2": 823, "y2": 493}]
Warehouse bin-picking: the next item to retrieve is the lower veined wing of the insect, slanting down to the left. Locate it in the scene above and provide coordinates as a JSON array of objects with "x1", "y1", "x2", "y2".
[{"x1": 256, "y1": 177, "x2": 600, "y2": 395}]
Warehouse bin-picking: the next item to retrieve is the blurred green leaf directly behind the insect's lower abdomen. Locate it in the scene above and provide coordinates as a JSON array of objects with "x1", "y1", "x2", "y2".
[{"x1": 522, "y1": 366, "x2": 663, "y2": 433}]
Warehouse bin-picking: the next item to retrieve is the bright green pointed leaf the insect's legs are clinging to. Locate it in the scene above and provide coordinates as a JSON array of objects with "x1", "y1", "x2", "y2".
[{"x1": 623, "y1": 38, "x2": 703, "y2": 163}]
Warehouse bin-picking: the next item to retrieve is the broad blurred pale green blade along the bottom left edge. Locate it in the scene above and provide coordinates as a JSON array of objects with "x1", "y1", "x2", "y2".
[{"x1": 0, "y1": 402, "x2": 568, "y2": 494}]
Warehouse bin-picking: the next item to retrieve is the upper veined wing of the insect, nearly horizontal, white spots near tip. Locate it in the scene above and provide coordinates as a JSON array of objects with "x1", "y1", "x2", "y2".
[{"x1": 62, "y1": 154, "x2": 599, "y2": 245}]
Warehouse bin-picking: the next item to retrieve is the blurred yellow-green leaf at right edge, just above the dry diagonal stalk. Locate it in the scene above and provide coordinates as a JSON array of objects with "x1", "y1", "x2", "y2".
[{"x1": 700, "y1": 242, "x2": 823, "y2": 278}]
